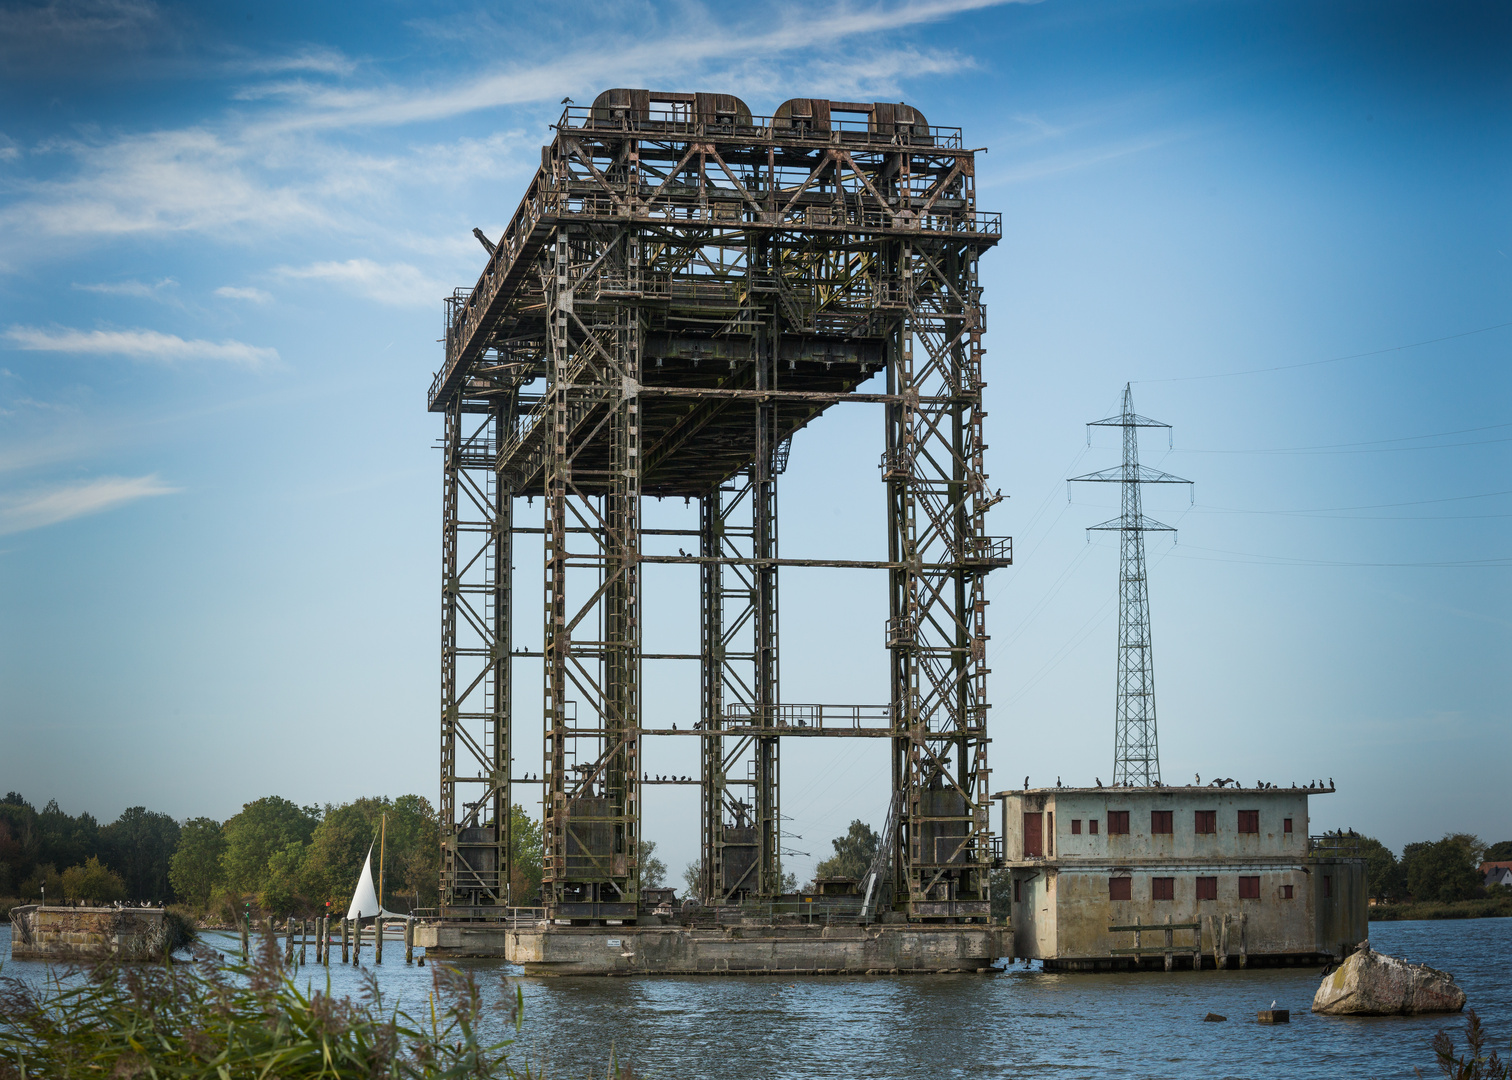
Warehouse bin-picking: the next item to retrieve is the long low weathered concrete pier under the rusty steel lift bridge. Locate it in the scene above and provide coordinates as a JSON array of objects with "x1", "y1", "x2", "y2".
[{"x1": 416, "y1": 924, "x2": 1009, "y2": 976}]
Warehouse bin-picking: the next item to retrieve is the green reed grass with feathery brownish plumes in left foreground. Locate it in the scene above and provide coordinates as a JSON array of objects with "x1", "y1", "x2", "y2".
[{"x1": 0, "y1": 919, "x2": 538, "y2": 1080}]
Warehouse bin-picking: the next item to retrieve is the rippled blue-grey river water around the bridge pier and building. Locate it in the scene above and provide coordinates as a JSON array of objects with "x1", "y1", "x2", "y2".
[{"x1": 0, "y1": 918, "x2": 1512, "y2": 1080}]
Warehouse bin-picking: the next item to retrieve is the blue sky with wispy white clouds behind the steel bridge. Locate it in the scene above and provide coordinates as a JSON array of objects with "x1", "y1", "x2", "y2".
[{"x1": 0, "y1": 0, "x2": 1512, "y2": 877}]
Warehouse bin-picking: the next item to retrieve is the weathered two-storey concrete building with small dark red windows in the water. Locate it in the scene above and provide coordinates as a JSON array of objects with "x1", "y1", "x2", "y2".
[{"x1": 995, "y1": 787, "x2": 1367, "y2": 971}]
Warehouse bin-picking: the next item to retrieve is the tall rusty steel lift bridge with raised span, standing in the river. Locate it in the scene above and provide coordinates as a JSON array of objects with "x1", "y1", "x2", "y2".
[{"x1": 429, "y1": 89, "x2": 1012, "y2": 924}]
